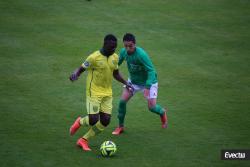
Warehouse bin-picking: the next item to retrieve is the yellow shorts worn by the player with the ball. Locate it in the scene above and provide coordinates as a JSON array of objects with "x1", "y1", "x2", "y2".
[{"x1": 86, "y1": 96, "x2": 113, "y2": 114}]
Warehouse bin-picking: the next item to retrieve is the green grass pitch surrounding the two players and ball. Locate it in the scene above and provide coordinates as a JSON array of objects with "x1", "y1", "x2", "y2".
[{"x1": 0, "y1": 0, "x2": 250, "y2": 167}]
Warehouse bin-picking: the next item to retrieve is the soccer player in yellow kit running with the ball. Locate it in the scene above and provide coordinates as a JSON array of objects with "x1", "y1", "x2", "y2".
[{"x1": 67, "y1": 34, "x2": 133, "y2": 151}]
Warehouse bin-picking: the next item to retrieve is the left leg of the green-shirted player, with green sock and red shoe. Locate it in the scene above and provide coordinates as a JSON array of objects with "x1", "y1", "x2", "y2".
[{"x1": 112, "y1": 88, "x2": 134, "y2": 135}]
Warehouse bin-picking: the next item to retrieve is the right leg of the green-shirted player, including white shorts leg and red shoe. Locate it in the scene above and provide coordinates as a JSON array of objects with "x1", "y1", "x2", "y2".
[{"x1": 147, "y1": 83, "x2": 167, "y2": 128}]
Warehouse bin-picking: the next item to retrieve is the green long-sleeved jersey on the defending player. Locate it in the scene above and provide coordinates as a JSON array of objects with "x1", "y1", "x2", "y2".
[{"x1": 118, "y1": 47, "x2": 157, "y2": 88}]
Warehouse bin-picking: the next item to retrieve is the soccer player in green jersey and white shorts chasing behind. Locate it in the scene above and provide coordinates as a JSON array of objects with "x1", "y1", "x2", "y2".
[{"x1": 112, "y1": 33, "x2": 167, "y2": 135}]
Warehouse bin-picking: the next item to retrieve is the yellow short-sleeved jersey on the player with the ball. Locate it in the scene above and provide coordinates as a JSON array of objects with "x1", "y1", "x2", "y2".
[{"x1": 82, "y1": 51, "x2": 119, "y2": 97}]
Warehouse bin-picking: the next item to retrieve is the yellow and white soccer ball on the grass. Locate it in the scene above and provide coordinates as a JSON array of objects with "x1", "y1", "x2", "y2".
[{"x1": 100, "y1": 141, "x2": 117, "y2": 157}]
